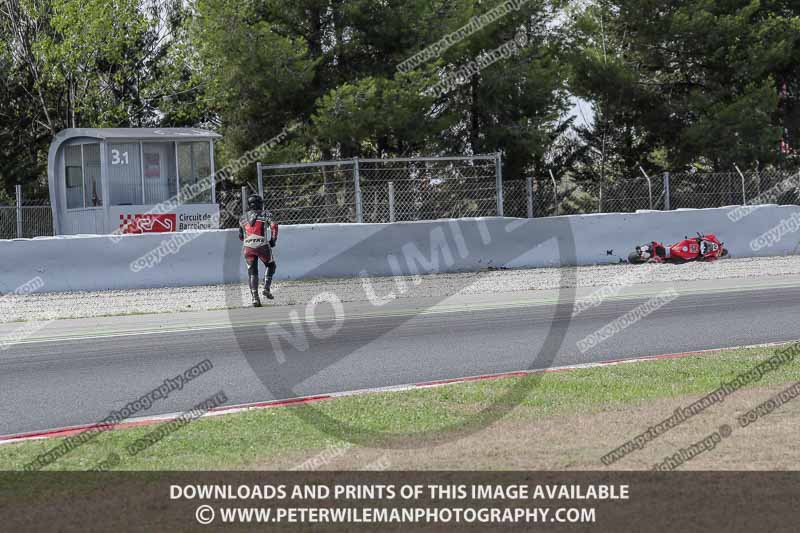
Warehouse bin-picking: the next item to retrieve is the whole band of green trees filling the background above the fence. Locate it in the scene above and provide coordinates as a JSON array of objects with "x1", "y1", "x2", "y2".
[{"x1": 0, "y1": 0, "x2": 800, "y2": 201}]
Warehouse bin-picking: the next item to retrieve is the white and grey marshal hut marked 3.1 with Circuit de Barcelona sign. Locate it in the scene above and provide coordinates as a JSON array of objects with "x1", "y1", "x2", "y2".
[{"x1": 47, "y1": 128, "x2": 220, "y2": 235}]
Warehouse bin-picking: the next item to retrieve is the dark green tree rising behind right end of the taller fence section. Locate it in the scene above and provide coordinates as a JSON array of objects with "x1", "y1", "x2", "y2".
[{"x1": 418, "y1": 0, "x2": 568, "y2": 178}]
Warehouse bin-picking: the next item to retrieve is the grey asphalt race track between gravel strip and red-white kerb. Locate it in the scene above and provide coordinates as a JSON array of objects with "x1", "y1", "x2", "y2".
[{"x1": 0, "y1": 276, "x2": 800, "y2": 435}]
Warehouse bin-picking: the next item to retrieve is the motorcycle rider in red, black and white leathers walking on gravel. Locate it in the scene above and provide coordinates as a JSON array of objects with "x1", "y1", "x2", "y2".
[{"x1": 239, "y1": 194, "x2": 278, "y2": 307}]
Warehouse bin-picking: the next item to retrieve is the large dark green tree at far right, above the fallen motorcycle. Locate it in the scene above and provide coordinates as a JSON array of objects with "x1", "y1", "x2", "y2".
[{"x1": 571, "y1": 0, "x2": 800, "y2": 172}]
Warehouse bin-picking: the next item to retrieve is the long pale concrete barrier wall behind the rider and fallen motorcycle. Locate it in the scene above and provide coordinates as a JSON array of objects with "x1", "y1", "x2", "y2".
[{"x1": 0, "y1": 206, "x2": 800, "y2": 294}]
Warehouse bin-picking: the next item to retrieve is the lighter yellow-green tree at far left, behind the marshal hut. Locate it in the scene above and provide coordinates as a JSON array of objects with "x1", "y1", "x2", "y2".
[{"x1": 0, "y1": 0, "x2": 202, "y2": 195}]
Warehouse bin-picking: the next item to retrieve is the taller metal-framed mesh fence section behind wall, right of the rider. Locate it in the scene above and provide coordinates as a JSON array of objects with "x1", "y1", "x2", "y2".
[{"x1": 255, "y1": 154, "x2": 503, "y2": 224}]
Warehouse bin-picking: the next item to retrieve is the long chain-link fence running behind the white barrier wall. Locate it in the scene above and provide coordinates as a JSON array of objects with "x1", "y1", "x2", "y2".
[{"x1": 6, "y1": 165, "x2": 800, "y2": 239}]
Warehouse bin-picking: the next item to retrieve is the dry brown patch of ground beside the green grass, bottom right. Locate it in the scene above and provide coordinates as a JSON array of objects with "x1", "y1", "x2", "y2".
[{"x1": 262, "y1": 384, "x2": 800, "y2": 470}]
